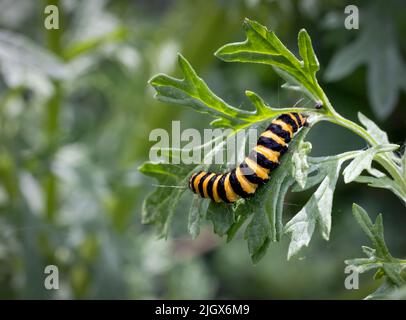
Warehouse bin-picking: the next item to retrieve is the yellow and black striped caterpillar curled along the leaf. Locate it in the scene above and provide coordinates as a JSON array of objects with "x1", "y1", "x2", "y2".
[{"x1": 189, "y1": 112, "x2": 307, "y2": 202}]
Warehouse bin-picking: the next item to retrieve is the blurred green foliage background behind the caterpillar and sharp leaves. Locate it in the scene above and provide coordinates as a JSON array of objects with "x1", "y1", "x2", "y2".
[{"x1": 0, "y1": 0, "x2": 406, "y2": 299}]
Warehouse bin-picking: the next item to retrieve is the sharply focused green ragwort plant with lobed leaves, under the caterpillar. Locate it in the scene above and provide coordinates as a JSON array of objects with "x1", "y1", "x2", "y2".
[{"x1": 140, "y1": 19, "x2": 406, "y2": 298}]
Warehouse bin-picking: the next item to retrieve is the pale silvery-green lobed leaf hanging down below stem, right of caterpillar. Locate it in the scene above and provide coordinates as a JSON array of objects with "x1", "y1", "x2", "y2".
[{"x1": 284, "y1": 160, "x2": 341, "y2": 259}]
